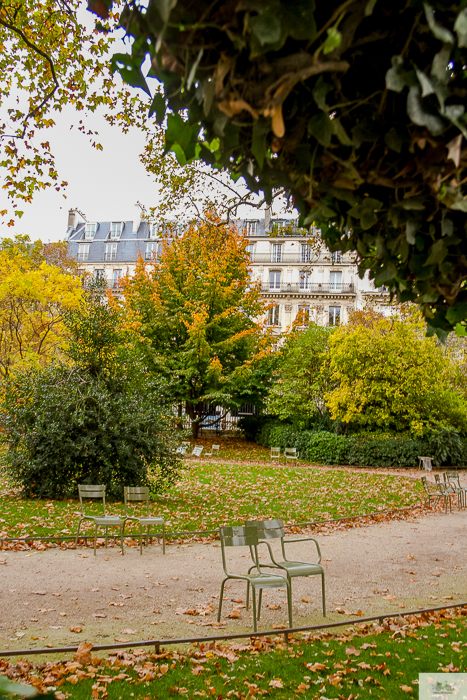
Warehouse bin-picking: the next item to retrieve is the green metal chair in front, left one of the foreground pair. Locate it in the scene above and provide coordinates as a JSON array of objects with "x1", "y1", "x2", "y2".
[{"x1": 217, "y1": 526, "x2": 292, "y2": 632}]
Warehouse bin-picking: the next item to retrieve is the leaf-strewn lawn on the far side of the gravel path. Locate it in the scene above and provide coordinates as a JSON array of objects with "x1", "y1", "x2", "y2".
[{"x1": 0, "y1": 462, "x2": 421, "y2": 537}]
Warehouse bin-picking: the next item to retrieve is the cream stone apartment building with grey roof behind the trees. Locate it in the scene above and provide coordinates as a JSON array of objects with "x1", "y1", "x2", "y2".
[{"x1": 66, "y1": 208, "x2": 389, "y2": 333}]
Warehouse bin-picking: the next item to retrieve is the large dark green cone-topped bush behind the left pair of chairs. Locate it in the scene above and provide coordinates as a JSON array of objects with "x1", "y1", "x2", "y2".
[{"x1": 0, "y1": 287, "x2": 180, "y2": 498}]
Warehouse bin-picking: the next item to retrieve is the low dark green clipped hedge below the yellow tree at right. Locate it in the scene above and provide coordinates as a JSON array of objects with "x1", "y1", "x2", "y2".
[{"x1": 256, "y1": 422, "x2": 467, "y2": 468}]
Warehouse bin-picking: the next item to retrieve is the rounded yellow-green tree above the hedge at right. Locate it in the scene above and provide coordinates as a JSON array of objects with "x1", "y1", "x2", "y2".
[{"x1": 326, "y1": 313, "x2": 467, "y2": 435}]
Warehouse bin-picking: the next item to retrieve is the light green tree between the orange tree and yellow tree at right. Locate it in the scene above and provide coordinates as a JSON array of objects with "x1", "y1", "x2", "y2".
[{"x1": 267, "y1": 323, "x2": 334, "y2": 429}]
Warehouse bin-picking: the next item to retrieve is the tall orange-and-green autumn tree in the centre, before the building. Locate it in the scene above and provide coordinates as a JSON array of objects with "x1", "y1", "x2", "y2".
[{"x1": 123, "y1": 213, "x2": 270, "y2": 437}]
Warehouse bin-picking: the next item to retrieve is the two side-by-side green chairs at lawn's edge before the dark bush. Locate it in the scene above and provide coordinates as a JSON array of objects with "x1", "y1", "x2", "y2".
[{"x1": 75, "y1": 484, "x2": 165, "y2": 556}]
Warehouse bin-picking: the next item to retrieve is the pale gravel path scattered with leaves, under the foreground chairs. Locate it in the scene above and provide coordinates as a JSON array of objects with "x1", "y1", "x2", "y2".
[{"x1": 0, "y1": 500, "x2": 467, "y2": 650}]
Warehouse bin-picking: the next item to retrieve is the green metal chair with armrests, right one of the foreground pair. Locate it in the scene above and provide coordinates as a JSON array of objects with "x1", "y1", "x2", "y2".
[{"x1": 245, "y1": 520, "x2": 326, "y2": 617}]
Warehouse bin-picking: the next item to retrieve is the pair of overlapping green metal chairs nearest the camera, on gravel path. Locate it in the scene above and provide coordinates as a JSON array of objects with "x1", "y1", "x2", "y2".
[{"x1": 217, "y1": 520, "x2": 326, "y2": 632}]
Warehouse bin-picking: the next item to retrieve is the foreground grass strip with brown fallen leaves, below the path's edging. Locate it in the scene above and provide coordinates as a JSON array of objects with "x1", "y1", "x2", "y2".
[{"x1": 0, "y1": 609, "x2": 467, "y2": 700}]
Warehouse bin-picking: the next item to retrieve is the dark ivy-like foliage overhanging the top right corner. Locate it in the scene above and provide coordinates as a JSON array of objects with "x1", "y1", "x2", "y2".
[{"x1": 100, "y1": 0, "x2": 467, "y2": 335}]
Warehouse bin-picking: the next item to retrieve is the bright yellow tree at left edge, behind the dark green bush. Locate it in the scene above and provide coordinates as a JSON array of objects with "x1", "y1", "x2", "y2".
[{"x1": 0, "y1": 237, "x2": 82, "y2": 379}]
